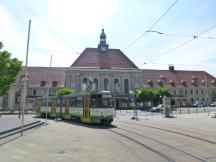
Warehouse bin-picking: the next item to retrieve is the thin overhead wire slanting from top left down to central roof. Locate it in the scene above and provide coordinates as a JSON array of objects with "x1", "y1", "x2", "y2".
[{"x1": 19, "y1": 0, "x2": 78, "y2": 53}]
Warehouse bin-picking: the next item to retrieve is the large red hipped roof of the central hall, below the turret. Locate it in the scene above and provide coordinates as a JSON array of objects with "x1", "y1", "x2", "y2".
[{"x1": 71, "y1": 48, "x2": 138, "y2": 69}]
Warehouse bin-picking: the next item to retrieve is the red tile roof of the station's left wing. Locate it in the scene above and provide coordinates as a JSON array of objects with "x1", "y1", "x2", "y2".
[{"x1": 16, "y1": 67, "x2": 66, "y2": 87}]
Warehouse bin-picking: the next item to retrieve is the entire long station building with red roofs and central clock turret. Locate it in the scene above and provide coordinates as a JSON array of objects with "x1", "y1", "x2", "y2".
[{"x1": 0, "y1": 29, "x2": 216, "y2": 109}]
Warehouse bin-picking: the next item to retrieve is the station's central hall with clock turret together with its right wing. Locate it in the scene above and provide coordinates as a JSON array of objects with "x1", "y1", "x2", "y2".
[{"x1": 66, "y1": 29, "x2": 216, "y2": 107}]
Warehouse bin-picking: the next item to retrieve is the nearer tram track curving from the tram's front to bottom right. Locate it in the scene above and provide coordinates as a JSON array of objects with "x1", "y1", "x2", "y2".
[{"x1": 108, "y1": 127, "x2": 208, "y2": 162}]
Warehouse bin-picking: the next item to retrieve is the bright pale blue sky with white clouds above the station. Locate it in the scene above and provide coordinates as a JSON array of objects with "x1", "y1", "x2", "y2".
[{"x1": 0, "y1": 0, "x2": 216, "y2": 76}]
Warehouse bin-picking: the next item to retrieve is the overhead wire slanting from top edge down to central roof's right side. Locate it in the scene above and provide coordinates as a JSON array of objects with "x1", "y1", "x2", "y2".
[{"x1": 123, "y1": 0, "x2": 178, "y2": 51}]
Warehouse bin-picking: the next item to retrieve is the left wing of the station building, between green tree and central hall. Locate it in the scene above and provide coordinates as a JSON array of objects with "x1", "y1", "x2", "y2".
[{"x1": 0, "y1": 67, "x2": 66, "y2": 111}]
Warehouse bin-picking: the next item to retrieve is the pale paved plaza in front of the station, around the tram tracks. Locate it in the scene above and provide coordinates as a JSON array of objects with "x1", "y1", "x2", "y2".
[{"x1": 0, "y1": 112, "x2": 216, "y2": 162}]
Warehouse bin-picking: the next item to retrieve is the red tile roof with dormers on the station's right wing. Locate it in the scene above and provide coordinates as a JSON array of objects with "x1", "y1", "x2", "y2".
[{"x1": 142, "y1": 70, "x2": 216, "y2": 86}]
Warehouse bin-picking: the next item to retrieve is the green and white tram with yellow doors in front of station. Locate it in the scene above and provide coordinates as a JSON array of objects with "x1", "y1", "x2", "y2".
[{"x1": 36, "y1": 92, "x2": 115, "y2": 124}]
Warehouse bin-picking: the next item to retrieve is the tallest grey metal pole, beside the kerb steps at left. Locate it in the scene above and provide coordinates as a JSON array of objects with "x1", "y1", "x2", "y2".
[{"x1": 21, "y1": 20, "x2": 31, "y2": 136}]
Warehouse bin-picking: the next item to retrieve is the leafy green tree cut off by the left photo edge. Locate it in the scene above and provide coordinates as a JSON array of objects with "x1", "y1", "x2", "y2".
[{"x1": 0, "y1": 42, "x2": 22, "y2": 96}]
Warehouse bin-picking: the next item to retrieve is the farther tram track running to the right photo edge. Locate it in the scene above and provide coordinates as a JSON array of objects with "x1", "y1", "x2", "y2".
[{"x1": 117, "y1": 120, "x2": 216, "y2": 144}]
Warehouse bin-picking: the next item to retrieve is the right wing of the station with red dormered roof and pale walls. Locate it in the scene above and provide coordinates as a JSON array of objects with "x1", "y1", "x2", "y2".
[{"x1": 142, "y1": 66, "x2": 216, "y2": 107}]
